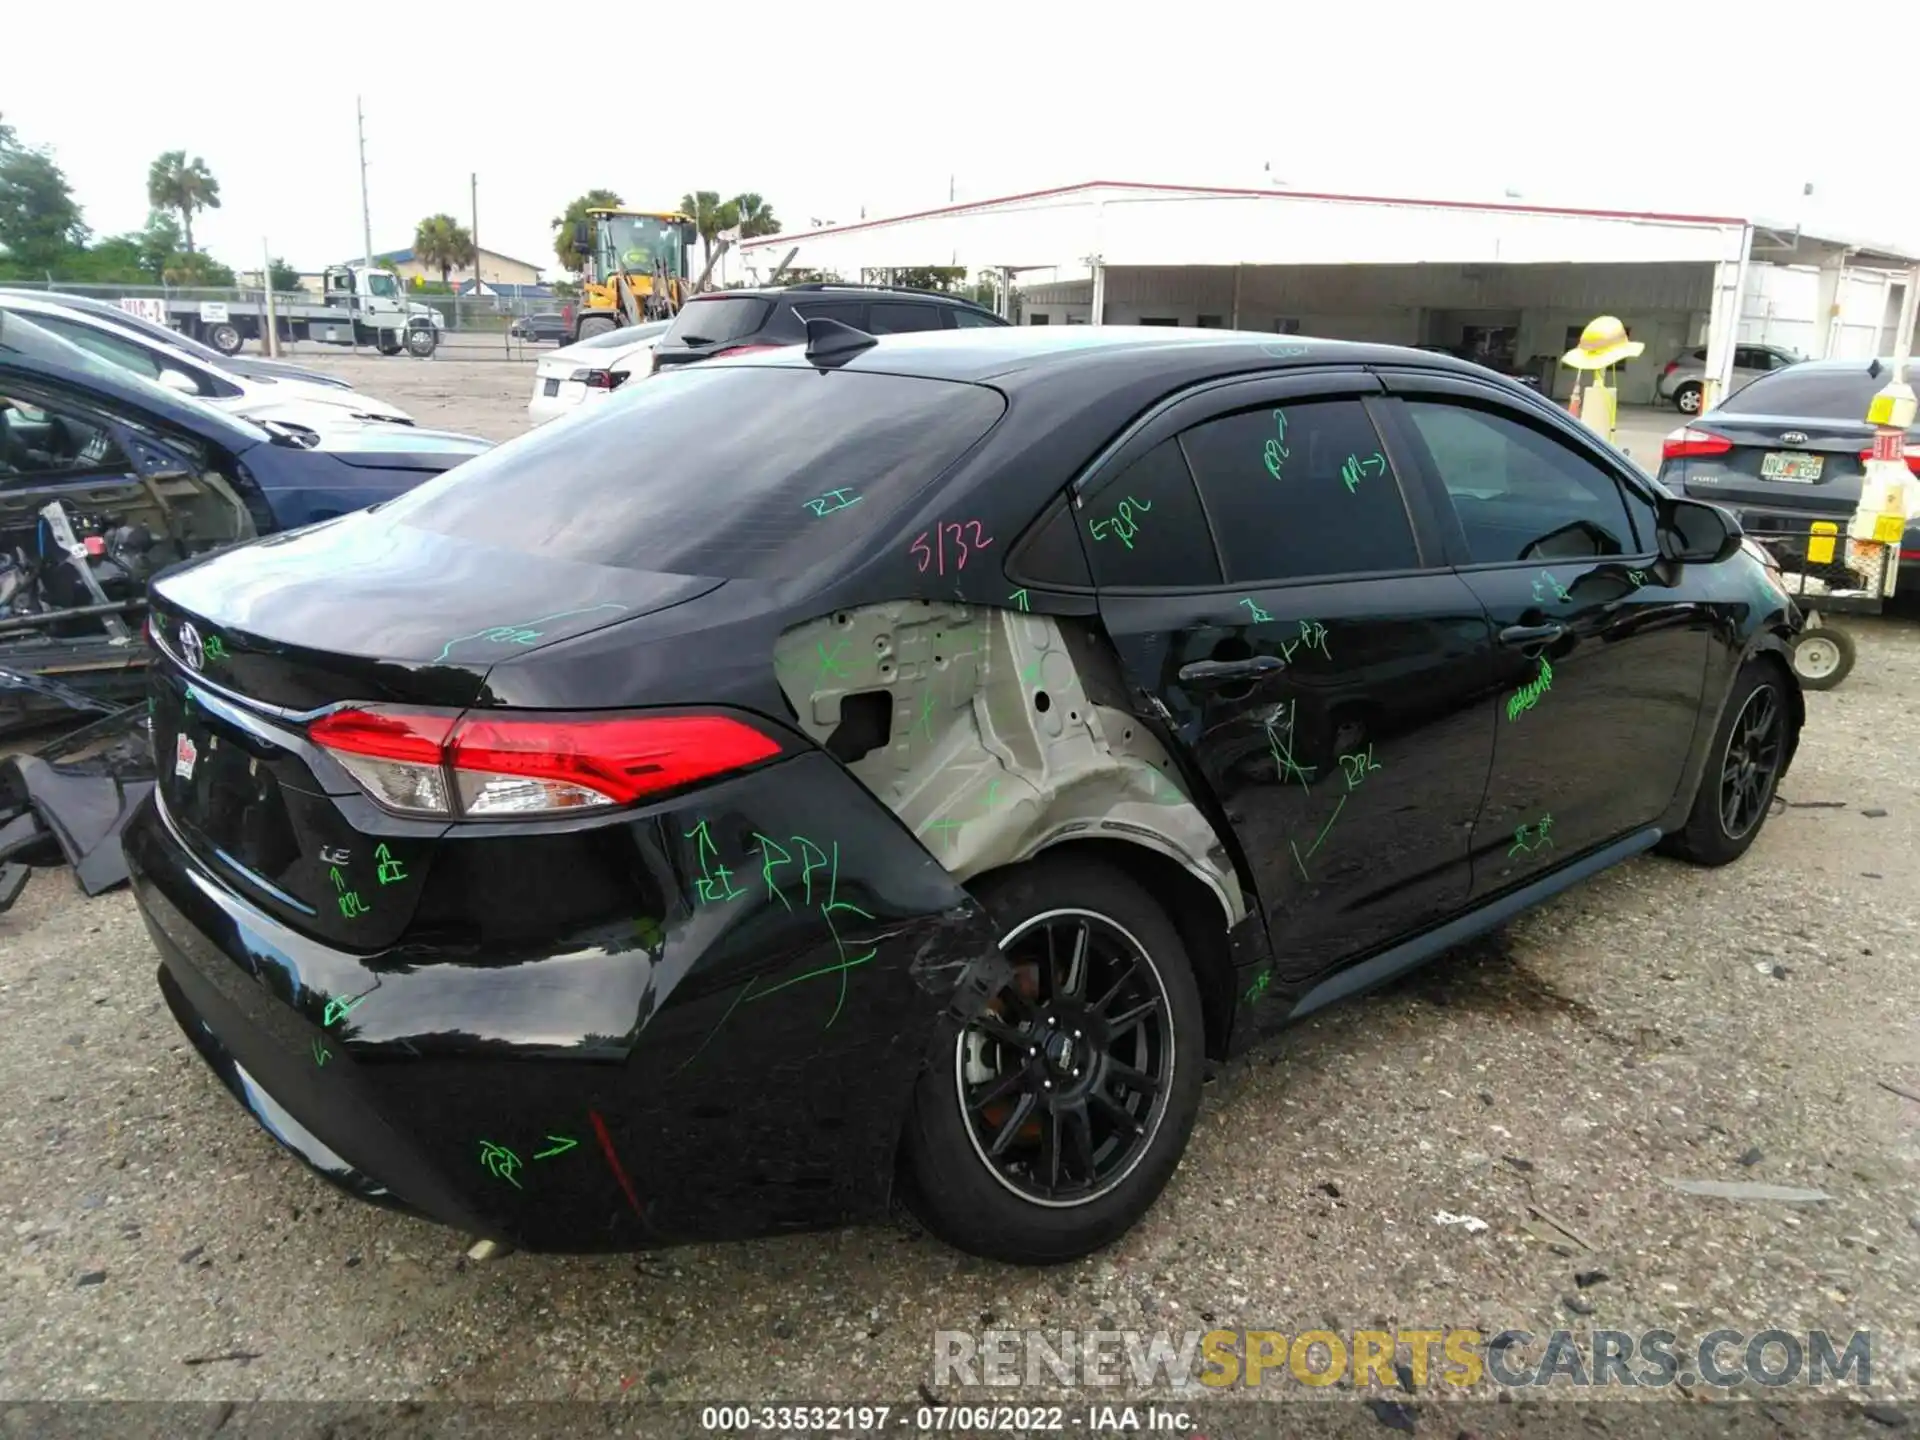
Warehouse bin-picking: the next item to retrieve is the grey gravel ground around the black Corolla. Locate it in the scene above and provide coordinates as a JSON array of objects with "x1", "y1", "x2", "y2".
[{"x1": 0, "y1": 357, "x2": 1920, "y2": 1434}]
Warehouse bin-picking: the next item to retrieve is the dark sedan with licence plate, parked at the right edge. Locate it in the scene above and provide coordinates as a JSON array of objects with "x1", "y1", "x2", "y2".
[{"x1": 1661, "y1": 359, "x2": 1920, "y2": 584}]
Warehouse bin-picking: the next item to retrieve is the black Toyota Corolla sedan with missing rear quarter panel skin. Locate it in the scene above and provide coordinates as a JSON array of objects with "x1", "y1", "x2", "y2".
[{"x1": 125, "y1": 319, "x2": 1801, "y2": 1261}]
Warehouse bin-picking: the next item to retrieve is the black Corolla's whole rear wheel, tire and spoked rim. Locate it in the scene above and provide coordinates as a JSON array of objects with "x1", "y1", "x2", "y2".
[{"x1": 906, "y1": 847, "x2": 1206, "y2": 1265}]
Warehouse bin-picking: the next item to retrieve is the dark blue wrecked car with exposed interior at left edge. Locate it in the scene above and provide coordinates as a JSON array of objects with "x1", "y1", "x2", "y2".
[{"x1": 0, "y1": 313, "x2": 490, "y2": 728}]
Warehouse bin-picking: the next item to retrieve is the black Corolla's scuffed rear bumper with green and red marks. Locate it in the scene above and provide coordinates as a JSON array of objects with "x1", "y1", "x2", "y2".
[{"x1": 123, "y1": 755, "x2": 998, "y2": 1252}]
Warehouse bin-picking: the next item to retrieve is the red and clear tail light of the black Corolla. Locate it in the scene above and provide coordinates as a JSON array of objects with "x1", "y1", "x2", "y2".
[{"x1": 307, "y1": 705, "x2": 780, "y2": 816}]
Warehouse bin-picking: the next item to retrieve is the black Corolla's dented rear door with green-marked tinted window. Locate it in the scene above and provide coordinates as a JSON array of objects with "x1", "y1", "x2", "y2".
[{"x1": 1079, "y1": 372, "x2": 1494, "y2": 1014}]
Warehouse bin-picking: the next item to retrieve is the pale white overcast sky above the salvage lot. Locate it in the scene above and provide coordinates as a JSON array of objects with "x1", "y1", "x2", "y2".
[{"x1": 0, "y1": 0, "x2": 1920, "y2": 269}]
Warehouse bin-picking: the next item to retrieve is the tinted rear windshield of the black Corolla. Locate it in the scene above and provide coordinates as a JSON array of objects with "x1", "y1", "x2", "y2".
[{"x1": 384, "y1": 362, "x2": 1004, "y2": 578}]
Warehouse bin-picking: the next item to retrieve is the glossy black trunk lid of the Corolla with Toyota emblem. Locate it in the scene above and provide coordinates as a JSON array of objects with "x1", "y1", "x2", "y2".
[{"x1": 150, "y1": 511, "x2": 724, "y2": 948}]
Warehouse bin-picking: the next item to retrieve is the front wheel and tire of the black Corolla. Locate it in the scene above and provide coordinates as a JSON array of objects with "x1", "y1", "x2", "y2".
[{"x1": 1661, "y1": 660, "x2": 1793, "y2": 866}]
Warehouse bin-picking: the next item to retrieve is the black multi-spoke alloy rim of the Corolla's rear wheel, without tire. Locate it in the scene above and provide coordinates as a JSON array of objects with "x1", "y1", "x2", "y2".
[{"x1": 954, "y1": 908, "x2": 1177, "y2": 1206}]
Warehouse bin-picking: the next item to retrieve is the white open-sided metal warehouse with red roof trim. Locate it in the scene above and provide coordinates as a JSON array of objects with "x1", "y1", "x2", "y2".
[{"x1": 741, "y1": 180, "x2": 1916, "y2": 401}]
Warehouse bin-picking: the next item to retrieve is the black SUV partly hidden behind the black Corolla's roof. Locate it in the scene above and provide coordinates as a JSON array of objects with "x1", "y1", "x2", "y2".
[{"x1": 653, "y1": 280, "x2": 1008, "y2": 371}]
